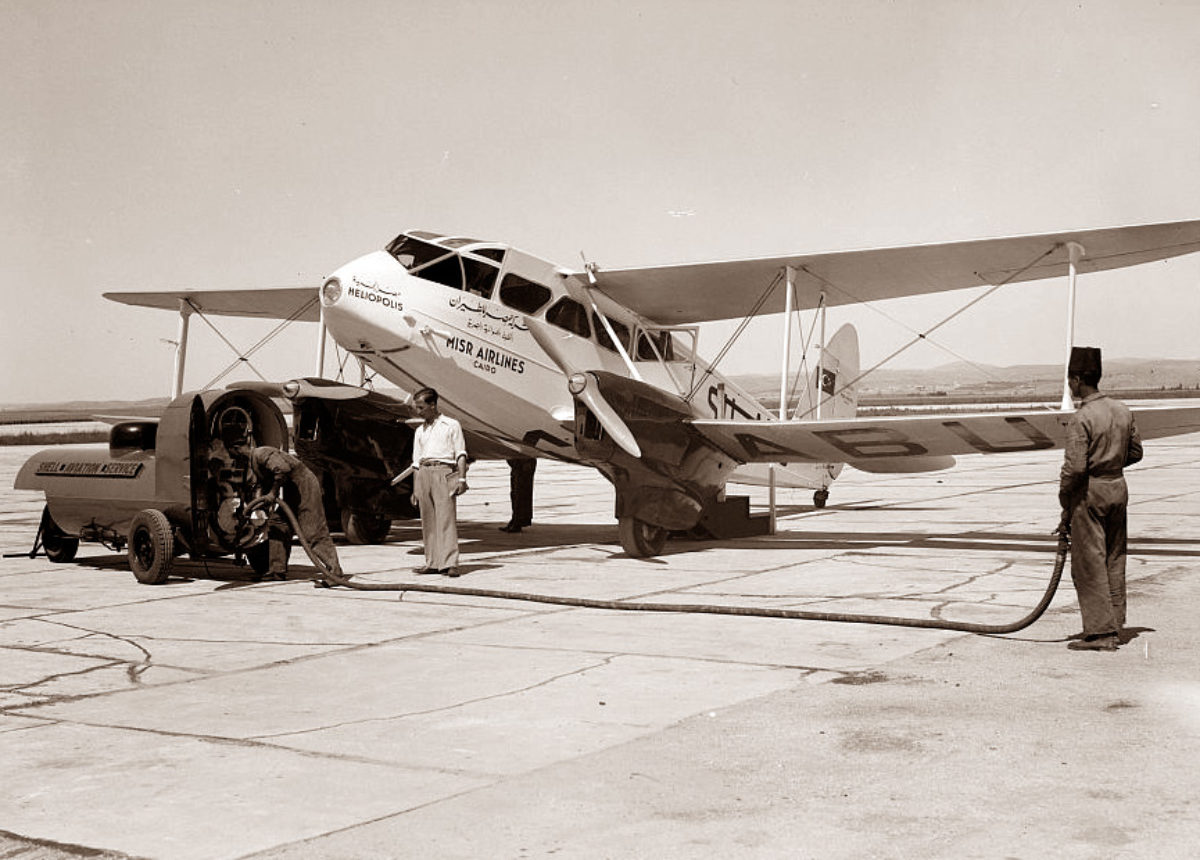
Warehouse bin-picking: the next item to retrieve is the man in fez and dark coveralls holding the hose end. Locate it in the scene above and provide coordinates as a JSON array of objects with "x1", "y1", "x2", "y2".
[{"x1": 1058, "y1": 347, "x2": 1141, "y2": 651}]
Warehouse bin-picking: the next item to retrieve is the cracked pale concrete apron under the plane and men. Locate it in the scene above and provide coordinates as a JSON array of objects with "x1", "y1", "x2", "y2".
[{"x1": 0, "y1": 437, "x2": 1200, "y2": 858}]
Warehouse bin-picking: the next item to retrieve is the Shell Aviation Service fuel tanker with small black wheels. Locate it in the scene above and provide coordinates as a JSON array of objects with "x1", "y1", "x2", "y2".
[{"x1": 13, "y1": 390, "x2": 288, "y2": 584}]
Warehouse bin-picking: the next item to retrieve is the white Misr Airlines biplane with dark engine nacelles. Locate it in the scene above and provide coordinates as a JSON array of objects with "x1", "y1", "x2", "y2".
[{"x1": 104, "y1": 221, "x2": 1200, "y2": 557}]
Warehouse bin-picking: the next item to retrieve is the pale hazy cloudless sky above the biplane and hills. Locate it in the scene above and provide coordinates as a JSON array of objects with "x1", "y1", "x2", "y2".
[{"x1": 0, "y1": 0, "x2": 1200, "y2": 403}]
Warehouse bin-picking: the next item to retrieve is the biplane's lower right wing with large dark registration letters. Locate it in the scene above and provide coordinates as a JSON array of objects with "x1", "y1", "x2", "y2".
[{"x1": 691, "y1": 407, "x2": 1200, "y2": 471}]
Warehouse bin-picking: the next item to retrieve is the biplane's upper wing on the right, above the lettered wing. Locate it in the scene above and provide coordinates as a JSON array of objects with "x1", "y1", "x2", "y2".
[{"x1": 576, "y1": 221, "x2": 1200, "y2": 325}]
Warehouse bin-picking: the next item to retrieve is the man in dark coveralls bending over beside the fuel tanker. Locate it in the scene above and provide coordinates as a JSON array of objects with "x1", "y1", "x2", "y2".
[{"x1": 223, "y1": 435, "x2": 344, "y2": 584}]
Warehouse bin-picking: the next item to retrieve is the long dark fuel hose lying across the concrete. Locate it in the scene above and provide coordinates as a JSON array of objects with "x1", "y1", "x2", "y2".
[{"x1": 260, "y1": 497, "x2": 1070, "y2": 635}]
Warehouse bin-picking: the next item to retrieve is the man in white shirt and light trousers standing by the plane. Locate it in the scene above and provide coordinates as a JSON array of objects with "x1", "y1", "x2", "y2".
[{"x1": 413, "y1": 389, "x2": 467, "y2": 577}]
